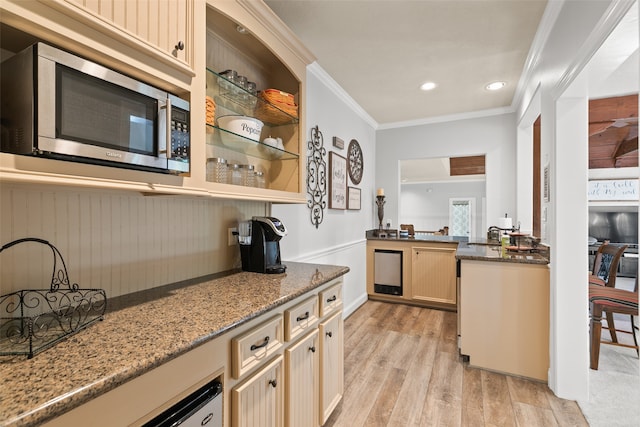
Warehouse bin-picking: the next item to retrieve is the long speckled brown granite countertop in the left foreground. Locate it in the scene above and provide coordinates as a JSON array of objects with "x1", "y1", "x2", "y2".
[{"x1": 0, "y1": 262, "x2": 349, "y2": 426}]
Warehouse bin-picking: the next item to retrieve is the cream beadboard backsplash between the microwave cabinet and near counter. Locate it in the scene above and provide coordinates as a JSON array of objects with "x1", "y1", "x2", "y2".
[{"x1": 0, "y1": 184, "x2": 269, "y2": 297}]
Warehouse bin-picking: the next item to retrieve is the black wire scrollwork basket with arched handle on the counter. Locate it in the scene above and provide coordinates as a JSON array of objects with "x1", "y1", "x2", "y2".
[{"x1": 0, "y1": 237, "x2": 107, "y2": 359}]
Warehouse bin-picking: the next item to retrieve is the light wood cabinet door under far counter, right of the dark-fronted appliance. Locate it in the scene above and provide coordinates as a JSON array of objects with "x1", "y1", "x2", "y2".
[{"x1": 411, "y1": 247, "x2": 456, "y2": 304}]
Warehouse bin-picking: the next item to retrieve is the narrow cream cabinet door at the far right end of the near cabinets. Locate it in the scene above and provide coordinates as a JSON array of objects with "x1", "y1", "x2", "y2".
[{"x1": 319, "y1": 310, "x2": 344, "y2": 425}]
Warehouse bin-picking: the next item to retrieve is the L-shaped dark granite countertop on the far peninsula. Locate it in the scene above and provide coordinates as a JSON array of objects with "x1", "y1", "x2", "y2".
[{"x1": 366, "y1": 230, "x2": 549, "y2": 264}]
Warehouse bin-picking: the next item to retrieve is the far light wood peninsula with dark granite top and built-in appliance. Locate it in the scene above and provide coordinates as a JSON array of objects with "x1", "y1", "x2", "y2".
[{"x1": 367, "y1": 230, "x2": 549, "y2": 381}]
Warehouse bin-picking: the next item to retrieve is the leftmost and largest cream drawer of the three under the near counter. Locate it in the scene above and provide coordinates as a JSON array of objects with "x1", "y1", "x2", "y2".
[{"x1": 231, "y1": 316, "x2": 282, "y2": 378}]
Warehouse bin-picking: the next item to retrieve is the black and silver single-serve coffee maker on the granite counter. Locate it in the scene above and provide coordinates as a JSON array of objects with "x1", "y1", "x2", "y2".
[{"x1": 238, "y1": 216, "x2": 287, "y2": 274}]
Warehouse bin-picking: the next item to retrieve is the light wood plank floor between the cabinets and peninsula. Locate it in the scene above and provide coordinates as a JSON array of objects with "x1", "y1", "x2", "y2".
[{"x1": 325, "y1": 301, "x2": 588, "y2": 427}]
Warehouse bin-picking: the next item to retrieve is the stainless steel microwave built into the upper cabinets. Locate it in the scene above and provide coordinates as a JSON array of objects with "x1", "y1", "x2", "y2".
[{"x1": 0, "y1": 43, "x2": 190, "y2": 174}]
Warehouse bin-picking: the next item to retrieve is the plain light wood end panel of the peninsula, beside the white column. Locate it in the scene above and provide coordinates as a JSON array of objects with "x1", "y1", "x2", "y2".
[{"x1": 459, "y1": 259, "x2": 552, "y2": 381}]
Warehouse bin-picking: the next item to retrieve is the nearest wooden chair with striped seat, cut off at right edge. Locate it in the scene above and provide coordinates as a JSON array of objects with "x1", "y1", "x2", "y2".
[{"x1": 589, "y1": 278, "x2": 640, "y2": 370}]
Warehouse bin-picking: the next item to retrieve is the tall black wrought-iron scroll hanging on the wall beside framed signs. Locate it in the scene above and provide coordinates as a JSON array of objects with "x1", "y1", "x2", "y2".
[{"x1": 307, "y1": 126, "x2": 327, "y2": 228}]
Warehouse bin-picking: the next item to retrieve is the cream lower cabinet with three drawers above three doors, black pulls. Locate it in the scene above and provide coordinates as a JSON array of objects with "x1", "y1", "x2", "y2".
[{"x1": 229, "y1": 279, "x2": 344, "y2": 427}]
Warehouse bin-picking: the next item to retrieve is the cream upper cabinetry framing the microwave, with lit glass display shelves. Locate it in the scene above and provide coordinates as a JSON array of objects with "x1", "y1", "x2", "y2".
[{"x1": 0, "y1": 0, "x2": 314, "y2": 203}]
